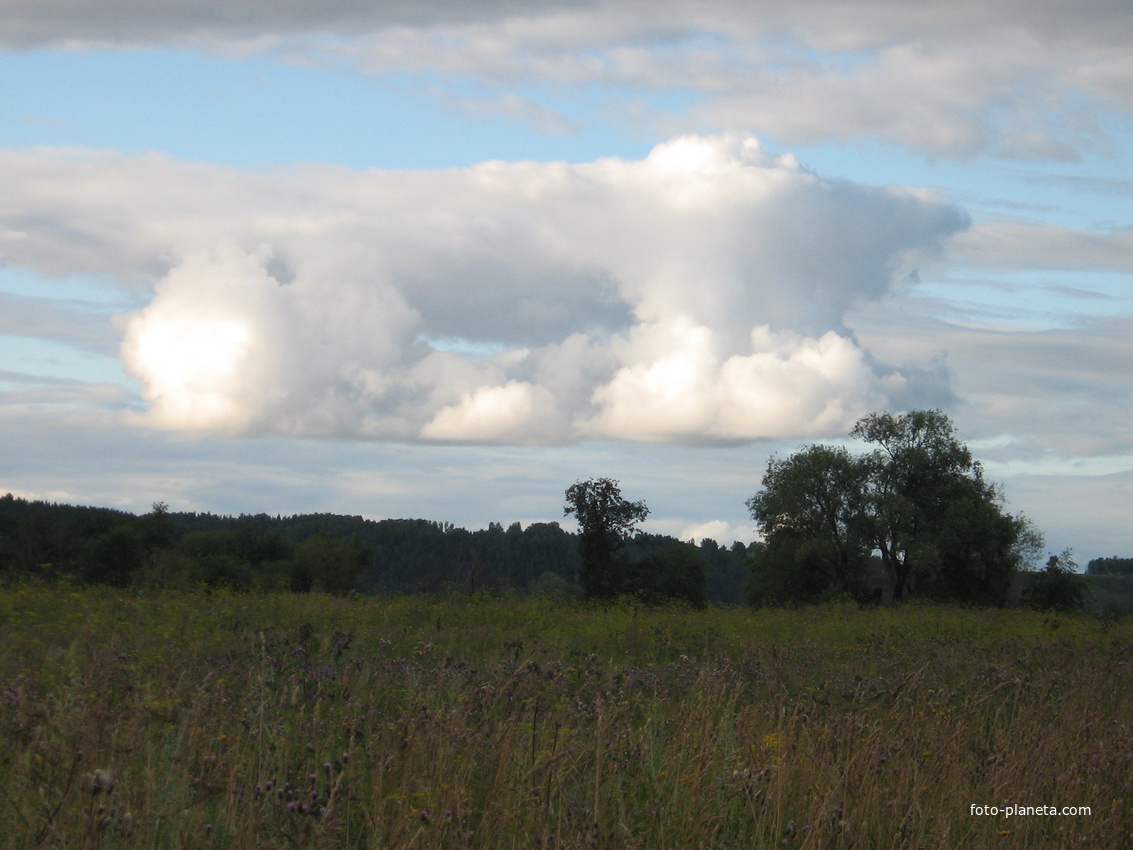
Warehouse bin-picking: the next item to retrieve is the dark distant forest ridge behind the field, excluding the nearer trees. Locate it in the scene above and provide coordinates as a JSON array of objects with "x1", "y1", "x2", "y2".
[{"x1": 0, "y1": 493, "x2": 750, "y2": 603}]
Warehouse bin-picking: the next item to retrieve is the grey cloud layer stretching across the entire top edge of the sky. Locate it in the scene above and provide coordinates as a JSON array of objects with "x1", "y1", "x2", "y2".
[{"x1": 0, "y1": 0, "x2": 1133, "y2": 160}]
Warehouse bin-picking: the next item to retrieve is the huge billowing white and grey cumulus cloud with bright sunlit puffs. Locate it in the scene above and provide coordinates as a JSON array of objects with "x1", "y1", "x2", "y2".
[{"x1": 0, "y1": 135, "x2": 968, "y2": 443}]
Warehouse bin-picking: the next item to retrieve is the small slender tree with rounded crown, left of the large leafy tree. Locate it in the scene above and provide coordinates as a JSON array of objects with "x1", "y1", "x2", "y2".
[{"x1": 563, "y1": 478, "x2": 649, "y2": 600}]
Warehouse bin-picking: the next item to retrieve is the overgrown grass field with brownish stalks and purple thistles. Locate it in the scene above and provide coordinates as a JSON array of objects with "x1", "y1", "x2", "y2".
[{"x1": 0, "y1": 587, "x2": 1133, "y2": 850}]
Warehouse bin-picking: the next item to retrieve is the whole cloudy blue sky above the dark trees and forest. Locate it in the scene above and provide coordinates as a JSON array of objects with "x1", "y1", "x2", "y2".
[{"x1": 0, "y1": 0, "x2": 1133, "y2": 566}]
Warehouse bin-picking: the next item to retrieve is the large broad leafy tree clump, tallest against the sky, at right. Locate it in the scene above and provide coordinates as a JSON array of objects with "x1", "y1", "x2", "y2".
[{"x1": 748, "y1": 410, "x2": 1041, "y2": 604}]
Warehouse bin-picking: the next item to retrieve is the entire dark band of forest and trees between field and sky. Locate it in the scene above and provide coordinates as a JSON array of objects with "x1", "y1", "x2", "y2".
[{"x1": 0, "y1": 410, "x2": 1096, "y2": 609}]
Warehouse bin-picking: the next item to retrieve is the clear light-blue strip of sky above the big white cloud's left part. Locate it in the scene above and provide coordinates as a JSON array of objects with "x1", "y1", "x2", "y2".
[{"x1": 0, "y1": 48, "x2": 650, "y2": 169}]
